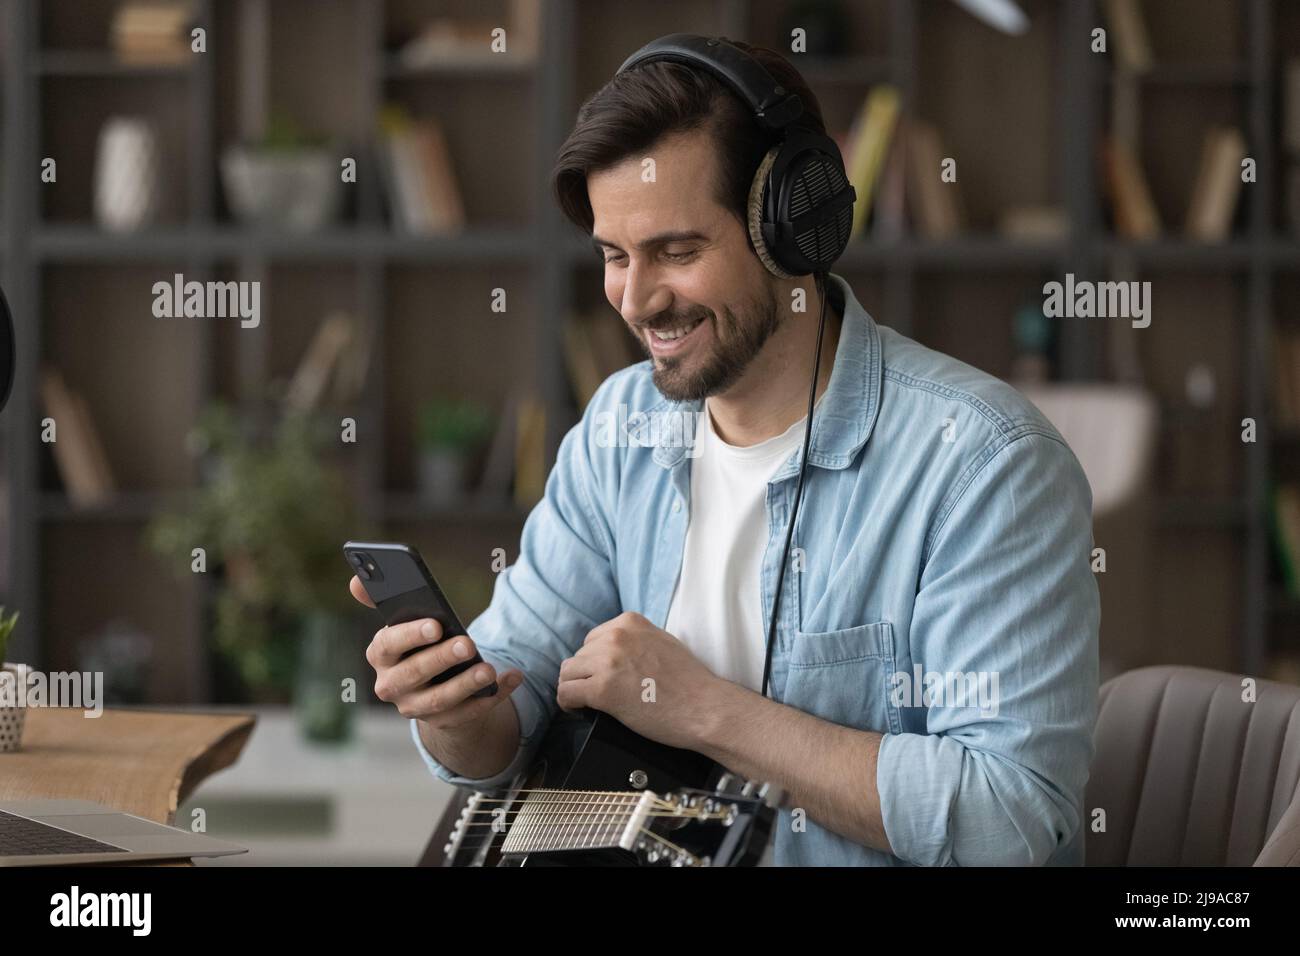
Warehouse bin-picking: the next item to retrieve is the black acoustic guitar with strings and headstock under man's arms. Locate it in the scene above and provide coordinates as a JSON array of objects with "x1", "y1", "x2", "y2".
[{"x1": 442, "y1": 710, "x2": 780, "y2": 866}]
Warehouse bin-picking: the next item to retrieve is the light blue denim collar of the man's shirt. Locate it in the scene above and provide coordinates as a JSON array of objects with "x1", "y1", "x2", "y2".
[{"x1": 650, "y1": 273, "x2": 884, "y2": 481}]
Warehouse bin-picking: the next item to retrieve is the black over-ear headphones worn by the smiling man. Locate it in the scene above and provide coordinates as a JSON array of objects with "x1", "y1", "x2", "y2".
[{"x1": 619, "y1": 34, "x2": 857, "y2": 278}]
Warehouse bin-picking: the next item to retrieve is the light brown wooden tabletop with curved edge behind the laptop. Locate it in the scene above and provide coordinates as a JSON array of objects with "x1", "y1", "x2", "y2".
[{"x1": 0, "y1": 708, "x2": 256, "y2": 825}]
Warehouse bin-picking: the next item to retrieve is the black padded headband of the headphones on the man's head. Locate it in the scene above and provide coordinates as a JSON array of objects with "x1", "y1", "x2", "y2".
[{"x1": 619, "y1": 34, "x2": 803, "y2": 131}]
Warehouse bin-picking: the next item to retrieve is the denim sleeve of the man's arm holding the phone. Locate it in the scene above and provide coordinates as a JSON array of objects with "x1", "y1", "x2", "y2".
[{"x1": 411, "y1": 376, "x2": 620, "y2": 790}]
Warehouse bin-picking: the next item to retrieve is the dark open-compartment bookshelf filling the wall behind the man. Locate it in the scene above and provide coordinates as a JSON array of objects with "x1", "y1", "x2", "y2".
[{"x1": 0, "y1": 0, "x2": 1300, "y2": 701}]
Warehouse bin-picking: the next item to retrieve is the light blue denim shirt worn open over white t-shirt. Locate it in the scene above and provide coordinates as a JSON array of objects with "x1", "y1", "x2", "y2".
[{"x1": 411, "y1": 276, "x2": 1100, "y2": 866}]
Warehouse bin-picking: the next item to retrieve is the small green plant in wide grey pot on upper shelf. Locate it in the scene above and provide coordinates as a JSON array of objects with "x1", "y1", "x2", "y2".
[{"x1": 221, "y1": 112, "x2": 343, "y2": 232}]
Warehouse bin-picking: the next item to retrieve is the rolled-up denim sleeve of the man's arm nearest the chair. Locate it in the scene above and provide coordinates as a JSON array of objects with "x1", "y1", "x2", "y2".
[{"x1": 876, "y1": 432, "x2": 1101, "y2": 866}]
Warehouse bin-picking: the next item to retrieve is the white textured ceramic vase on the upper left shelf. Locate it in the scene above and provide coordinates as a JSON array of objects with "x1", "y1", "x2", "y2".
[{"x1": 95, "y1": 116, "x2": 163, "y2": 233}]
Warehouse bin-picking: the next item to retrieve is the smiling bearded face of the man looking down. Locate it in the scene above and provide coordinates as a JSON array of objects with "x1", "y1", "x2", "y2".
[{"x1": 588, "y1": 133, "x2": 781, "y2": 402}]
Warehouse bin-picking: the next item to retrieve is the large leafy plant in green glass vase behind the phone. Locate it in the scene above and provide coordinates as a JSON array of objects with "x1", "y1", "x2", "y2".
[{"x1": 147, "y1": 403, "x2": 365, "y2": 739}]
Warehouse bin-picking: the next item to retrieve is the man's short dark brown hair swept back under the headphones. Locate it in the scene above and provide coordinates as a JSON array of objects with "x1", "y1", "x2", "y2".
[{"x1": 551, "y1": 40, "x2": 826, "y2": 233}]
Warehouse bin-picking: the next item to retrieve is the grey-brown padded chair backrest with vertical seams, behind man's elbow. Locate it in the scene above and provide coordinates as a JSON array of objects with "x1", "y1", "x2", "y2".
[{"x1": 1084, "y1": 666, "x2": 1300, "y2": 866}]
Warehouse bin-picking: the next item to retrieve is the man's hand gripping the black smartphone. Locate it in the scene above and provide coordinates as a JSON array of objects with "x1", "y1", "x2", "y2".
[{"x1": 348, "y1": 575, "x2": 524, "y2": 731}]
